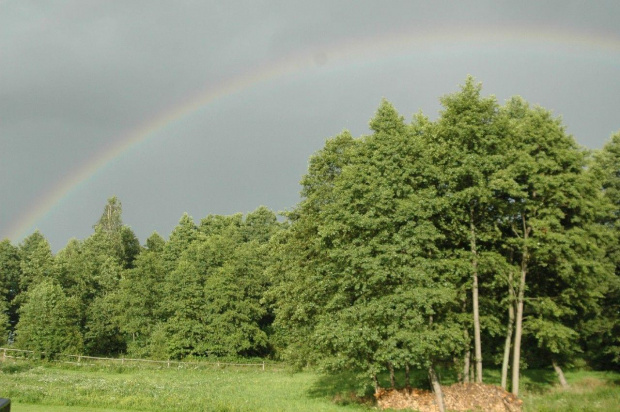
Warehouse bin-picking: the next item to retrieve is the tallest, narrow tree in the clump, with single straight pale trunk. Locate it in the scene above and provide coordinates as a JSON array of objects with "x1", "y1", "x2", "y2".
[{"x1": 436, "y1": 76, "x2": 506, "y2": 382}]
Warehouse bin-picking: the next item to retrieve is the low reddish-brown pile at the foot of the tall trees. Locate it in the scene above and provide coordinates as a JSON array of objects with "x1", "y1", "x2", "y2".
[{"x1": 375, "y1": 383, "x2": 522, "y2": 412}]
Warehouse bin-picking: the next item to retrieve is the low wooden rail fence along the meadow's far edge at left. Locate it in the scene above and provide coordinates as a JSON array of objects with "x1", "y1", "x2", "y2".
[{"x1": 0, "y1": 348, "x2": 265, "y2": 370}]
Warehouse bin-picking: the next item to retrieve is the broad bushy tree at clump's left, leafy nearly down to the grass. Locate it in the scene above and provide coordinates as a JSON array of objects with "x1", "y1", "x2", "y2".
[{"x1": 274, "y1": 101, "x2": 462, "y2": 406}]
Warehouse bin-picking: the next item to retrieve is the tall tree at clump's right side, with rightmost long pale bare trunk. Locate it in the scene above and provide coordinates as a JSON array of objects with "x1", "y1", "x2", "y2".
[{"x1": 495, "y1": 98, "x2": 604, "y2": 395}]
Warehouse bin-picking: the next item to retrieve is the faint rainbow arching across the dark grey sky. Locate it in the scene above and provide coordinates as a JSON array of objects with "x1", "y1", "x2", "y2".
[{"x1": 7, "y1": 26, "x2": 620, "y2": 241}]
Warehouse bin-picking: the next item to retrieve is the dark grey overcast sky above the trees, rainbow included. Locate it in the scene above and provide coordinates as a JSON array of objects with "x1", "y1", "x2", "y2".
[{"x1": 0, "y1": 0, "x2": 620, "y2": 251}]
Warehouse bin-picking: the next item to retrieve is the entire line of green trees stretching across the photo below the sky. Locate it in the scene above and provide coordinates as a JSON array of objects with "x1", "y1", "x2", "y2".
[{"x1": 0, "y1": 77, "x2": 620, "y2": 394}]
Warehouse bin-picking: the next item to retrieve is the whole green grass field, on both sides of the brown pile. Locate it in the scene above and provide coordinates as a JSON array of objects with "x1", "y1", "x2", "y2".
[{"x1": 0, "y1": 362, "x2": 620, "y2": 412}]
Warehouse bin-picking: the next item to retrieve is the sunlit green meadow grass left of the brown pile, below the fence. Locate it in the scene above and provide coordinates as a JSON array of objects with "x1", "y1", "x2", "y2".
[{"x1": 0, "y1": 363, "x2": 368, "y2": 412}]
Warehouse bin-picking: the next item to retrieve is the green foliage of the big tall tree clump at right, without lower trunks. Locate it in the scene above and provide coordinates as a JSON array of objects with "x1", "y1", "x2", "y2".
[{"x1": 267, "y1": 77, "x2": 620, "y2": 396}]
